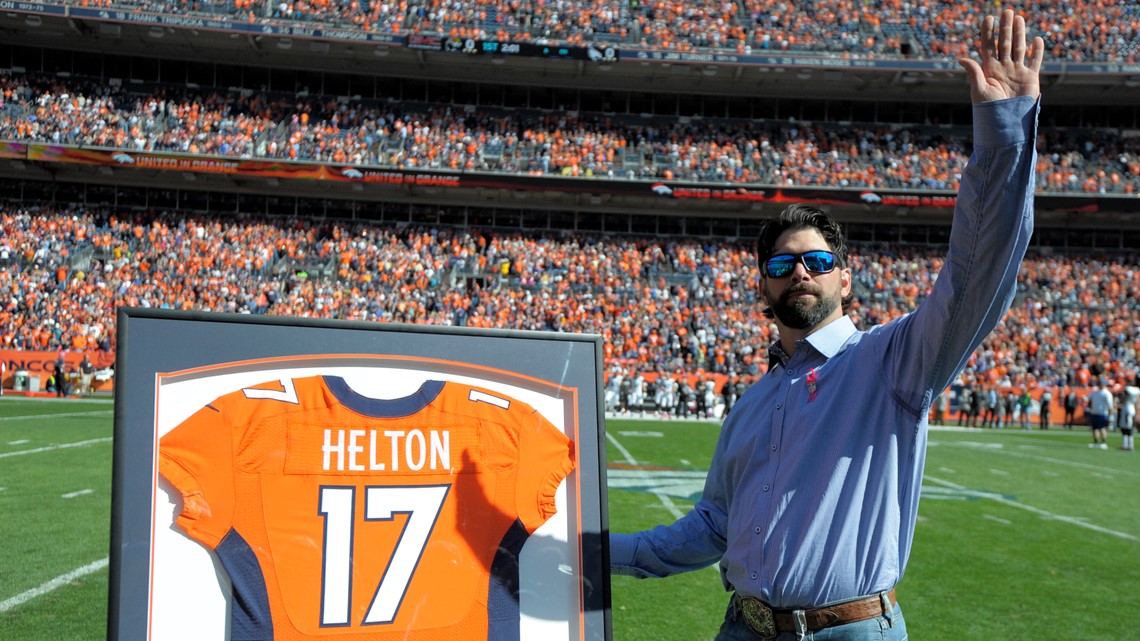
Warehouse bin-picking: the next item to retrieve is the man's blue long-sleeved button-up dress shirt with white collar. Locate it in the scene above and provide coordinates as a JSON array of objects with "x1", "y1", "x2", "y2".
[{"x1": 610, "y1": 97, "x2": 1039, "y2": 608}]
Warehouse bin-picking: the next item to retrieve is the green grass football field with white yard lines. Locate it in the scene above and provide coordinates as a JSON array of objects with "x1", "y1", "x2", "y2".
[{"x1": 0, "y1": 397, "x2": 1140, "y2": 641}]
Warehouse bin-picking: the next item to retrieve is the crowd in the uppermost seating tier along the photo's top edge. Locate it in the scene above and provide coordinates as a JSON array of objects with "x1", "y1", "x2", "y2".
[{"x1": 44, "y1": 0, "x2": 1140, "y2": 63}]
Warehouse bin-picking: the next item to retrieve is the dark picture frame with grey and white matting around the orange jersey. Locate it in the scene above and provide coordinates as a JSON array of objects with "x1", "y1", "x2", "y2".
[{"x1": 107, "y1": 308, "x2": 612, "y2": 641}]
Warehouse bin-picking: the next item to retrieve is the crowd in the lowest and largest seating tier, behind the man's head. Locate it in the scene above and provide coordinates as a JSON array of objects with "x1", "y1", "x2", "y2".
[{"x1": 0, "y1": 205, "x2": 1140, "y2": 403}]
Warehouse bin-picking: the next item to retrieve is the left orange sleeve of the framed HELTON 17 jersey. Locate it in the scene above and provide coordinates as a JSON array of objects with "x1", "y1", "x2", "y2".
[{"x1": 158, "y1": 405, "x2": 236, "y2": 542}]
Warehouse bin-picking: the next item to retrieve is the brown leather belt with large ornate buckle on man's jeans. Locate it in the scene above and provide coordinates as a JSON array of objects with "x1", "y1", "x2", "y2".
[{"x1": 733, "y1": 590, "x2": 897, "y2": 639}]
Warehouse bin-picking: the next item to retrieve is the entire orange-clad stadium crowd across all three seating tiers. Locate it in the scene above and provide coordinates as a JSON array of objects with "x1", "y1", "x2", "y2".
[{"x1": 0, "y1": 0, "x2": 1140, "y2": 409}]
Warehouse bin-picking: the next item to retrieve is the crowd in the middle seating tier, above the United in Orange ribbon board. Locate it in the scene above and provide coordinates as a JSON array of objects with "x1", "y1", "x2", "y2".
[{"x1": 0, "y1": 75, "x2": 1140, "y2": 194}]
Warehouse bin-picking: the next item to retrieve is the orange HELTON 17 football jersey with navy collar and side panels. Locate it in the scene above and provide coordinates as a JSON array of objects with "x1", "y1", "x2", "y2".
[{"x1": 158, "y1": 376, "x2": 573, "y2": 641}]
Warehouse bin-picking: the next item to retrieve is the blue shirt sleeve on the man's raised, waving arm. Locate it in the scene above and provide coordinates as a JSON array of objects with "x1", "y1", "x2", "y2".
[{"x1": 879, "y1": 97, "x2": 1040, "y2": 414}]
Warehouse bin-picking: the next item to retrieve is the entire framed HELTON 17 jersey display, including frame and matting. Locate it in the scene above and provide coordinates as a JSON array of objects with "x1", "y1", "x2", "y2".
[{"x1": 108, "y1": 309, "x2": 610, "y2": 641}]
